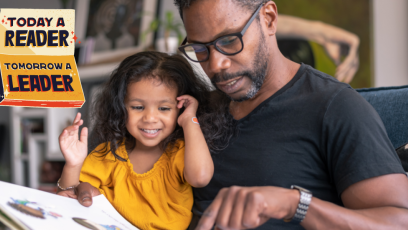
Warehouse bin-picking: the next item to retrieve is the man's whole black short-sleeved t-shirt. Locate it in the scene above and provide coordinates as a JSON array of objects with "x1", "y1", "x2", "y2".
[{"x1": 190, "y1": 64, "x2": 405, "y2": 229}]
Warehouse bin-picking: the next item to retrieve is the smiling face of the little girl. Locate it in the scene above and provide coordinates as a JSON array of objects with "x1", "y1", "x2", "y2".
[{"x1": 125, "y1": 78, "x2": 179, "y2": 148}]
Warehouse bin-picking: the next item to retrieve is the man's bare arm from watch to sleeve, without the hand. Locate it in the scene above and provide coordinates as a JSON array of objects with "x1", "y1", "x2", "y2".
[{"x1": 301, "y1": 174, "x2": 408, "y2": 229}]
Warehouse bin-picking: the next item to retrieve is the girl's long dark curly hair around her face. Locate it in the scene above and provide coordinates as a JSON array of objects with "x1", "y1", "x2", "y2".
[{"x1": 91, "y1": 51, "x2": 235, "y2": 161}]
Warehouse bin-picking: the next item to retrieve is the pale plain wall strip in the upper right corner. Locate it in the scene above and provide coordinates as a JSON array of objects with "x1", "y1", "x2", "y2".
[{"x1": 373, "y1": 0, "x2": 408, "y2": 87}]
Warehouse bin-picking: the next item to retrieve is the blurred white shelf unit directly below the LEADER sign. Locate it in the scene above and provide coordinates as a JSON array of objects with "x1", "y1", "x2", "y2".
[{"x1": 10, "y1": 107, "x2": 77, "y2": 188}]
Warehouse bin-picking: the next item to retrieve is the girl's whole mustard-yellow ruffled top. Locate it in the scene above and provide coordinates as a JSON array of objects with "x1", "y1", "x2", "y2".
[{"x1": 79, "y1": 140, "x2": 193, "y2": 229}]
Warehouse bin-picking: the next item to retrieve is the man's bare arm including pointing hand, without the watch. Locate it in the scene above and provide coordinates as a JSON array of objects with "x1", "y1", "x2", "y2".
[{"x1": 196, "y1": 174, "x2": 408, "y2": 230}]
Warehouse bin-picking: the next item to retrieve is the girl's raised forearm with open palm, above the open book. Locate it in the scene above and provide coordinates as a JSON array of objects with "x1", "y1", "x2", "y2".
[{"x1": 57, "y1": 113, "x2": 88, "y2": 193}]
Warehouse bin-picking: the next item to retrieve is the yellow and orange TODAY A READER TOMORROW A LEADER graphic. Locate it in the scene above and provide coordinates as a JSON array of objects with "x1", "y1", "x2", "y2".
[{"x1": 0, "y1": 9, "x2": 85, "y2": 108}]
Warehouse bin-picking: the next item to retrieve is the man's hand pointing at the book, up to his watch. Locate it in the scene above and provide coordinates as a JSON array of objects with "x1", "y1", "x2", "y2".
[{"x1": 196, "y1": 186, "x2": 300, "y2": 230}]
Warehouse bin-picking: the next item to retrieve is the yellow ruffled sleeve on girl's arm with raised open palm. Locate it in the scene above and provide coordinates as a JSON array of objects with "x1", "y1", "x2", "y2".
[{"x1": 79, "y1": 143, "x2": 117, "y2": 193}]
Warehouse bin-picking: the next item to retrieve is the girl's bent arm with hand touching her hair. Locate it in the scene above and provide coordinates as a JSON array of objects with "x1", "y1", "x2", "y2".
[{"x1": 177, "y1": 95, "x2": 214, "y2": 188}]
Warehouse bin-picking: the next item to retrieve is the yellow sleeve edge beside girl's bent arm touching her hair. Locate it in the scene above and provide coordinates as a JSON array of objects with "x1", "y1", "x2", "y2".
[{"x1": 170, "y1": 140, "x2": 187, "y2": 188}]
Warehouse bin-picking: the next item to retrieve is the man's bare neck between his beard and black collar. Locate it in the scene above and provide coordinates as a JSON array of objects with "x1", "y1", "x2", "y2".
[{"x1": 230, "y1": 55, "x2": 300, "y2": 120}]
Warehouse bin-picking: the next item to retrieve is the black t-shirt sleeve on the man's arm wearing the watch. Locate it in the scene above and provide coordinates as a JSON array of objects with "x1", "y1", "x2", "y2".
[{"x1": 322, "y1": 88, "x2": 405, "y2": 195}]
